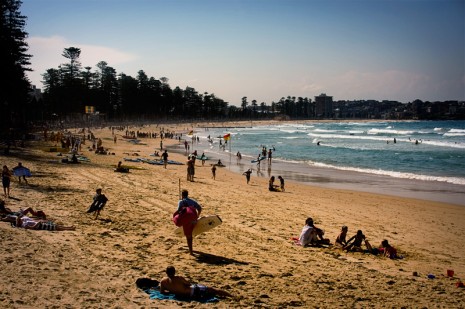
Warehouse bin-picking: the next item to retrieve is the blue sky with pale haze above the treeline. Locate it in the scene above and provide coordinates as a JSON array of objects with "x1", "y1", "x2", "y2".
[{"x1": 20, "y1": 0, "x2": 465, "y2": 106}]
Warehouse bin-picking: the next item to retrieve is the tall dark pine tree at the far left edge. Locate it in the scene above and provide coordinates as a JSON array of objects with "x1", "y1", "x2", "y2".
[{"x1": 0, "y1": 0, "x2": 32, "y2": 132}]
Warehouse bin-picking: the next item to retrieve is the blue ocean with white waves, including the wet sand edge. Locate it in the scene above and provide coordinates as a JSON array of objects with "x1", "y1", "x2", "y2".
[{"x1": 173, "y1": 121, "x2": 465, "y2": 205}]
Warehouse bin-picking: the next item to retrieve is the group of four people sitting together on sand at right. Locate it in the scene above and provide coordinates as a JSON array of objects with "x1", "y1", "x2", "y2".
[{"x1": 298, "y1": 218, "x2": 401, "y2": 259}]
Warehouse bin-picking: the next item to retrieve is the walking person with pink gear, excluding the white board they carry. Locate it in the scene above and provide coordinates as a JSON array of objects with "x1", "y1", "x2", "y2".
[{"x1": 172, "y1": 189, "x2": 202, "y2": 255}]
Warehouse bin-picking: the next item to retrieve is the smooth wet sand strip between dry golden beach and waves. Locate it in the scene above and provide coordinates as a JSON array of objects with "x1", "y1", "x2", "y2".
[{"x1": 170, "y1": 144, "x2": 465, "y2": 206}]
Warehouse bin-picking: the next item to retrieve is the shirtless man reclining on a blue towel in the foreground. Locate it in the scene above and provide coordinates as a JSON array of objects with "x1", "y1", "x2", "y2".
[{"x1": 160, "y1": 266, "x2": 232, "y2": 299}]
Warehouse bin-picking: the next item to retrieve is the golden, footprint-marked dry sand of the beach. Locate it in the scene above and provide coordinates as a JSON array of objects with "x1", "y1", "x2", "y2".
[{"x1": 0, "y1": 124, "x2": 465, "y2": 308}]
